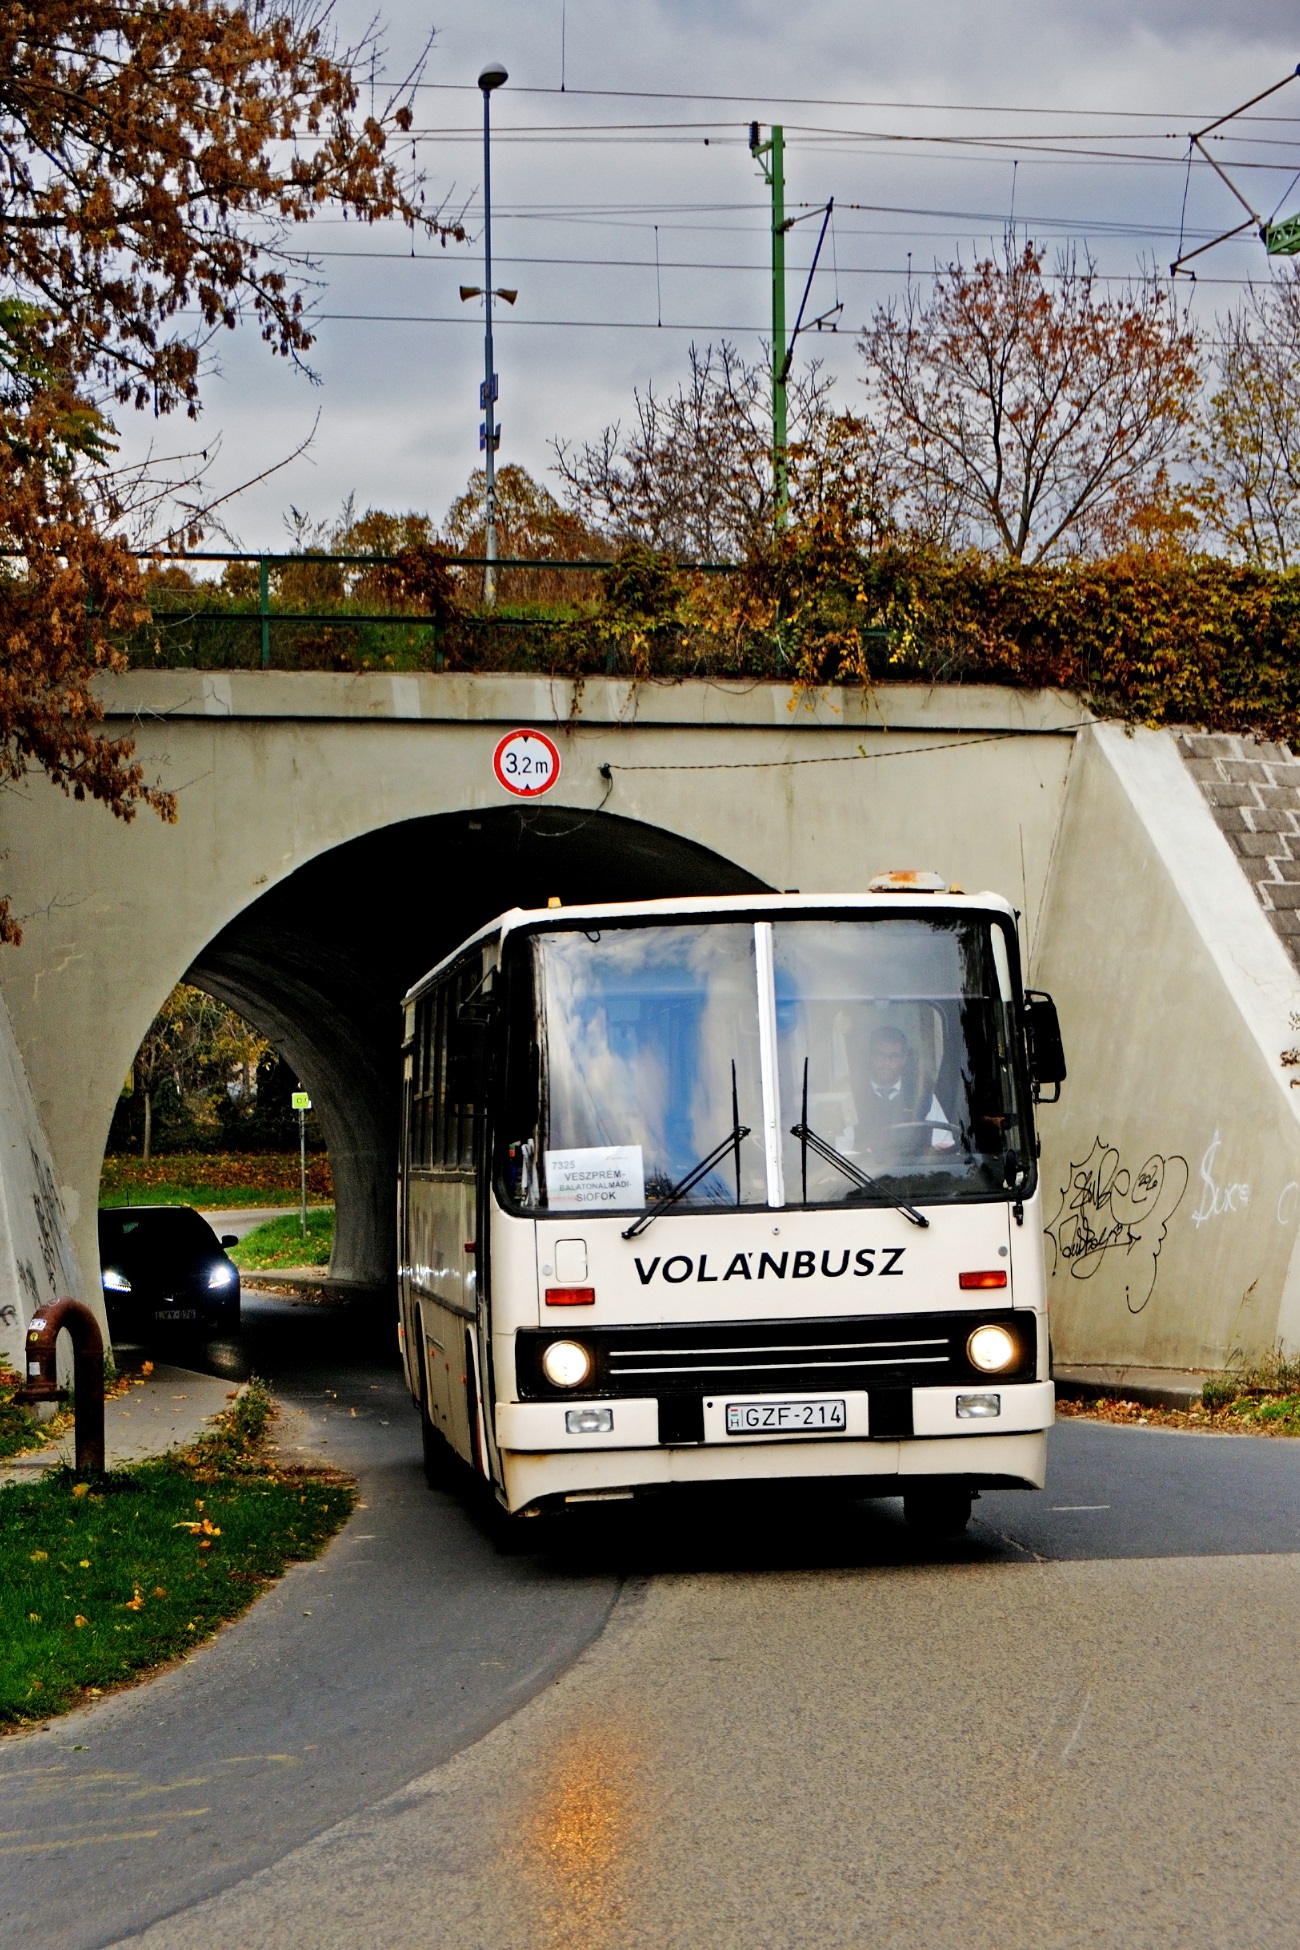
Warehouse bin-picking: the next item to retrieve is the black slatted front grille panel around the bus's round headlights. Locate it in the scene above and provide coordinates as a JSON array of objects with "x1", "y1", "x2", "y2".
[{"x1": 516, "y1": 1308, "x2": 1037, "y2": 1402}]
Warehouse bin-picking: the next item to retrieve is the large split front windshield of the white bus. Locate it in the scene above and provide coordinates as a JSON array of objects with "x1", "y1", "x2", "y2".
[{"x1": 501, "y1": 913, "x2": 1031, "y2": 1213}]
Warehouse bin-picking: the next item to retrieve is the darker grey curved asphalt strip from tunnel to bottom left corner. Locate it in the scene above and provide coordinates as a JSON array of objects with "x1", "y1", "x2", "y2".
[{"x1": 0, "y1": 1297, "x2": 618, "y2": 1950}]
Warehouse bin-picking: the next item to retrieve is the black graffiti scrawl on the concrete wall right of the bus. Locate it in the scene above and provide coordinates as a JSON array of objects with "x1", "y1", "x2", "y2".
[{"x1": 1045, "y1": 1137, "x2": 1189, "y2": 1314}]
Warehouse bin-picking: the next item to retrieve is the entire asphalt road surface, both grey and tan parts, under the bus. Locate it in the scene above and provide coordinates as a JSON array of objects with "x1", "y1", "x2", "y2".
[{"x1": 0, "y1": 1310, "x2": 1300, "y2": 1950}]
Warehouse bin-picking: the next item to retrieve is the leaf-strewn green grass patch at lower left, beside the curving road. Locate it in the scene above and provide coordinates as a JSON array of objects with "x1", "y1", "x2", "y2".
[{"x1": 0, "y1": 1383, "x2": 355, "y2": 1730}]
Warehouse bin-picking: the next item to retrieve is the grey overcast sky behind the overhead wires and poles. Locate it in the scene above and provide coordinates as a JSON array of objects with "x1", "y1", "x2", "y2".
[{"x1": 123, "y1": 0, "x2": 1300, "y2": 548}]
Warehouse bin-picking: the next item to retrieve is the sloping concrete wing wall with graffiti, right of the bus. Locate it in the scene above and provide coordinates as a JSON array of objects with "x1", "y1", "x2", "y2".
[{"x1": 1033, "y1": 725, "x2": 1300, "y2": 1367}]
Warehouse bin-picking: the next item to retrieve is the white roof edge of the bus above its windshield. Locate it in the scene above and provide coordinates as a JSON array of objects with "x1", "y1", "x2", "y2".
[{"x1": 401, "y1": 891, "x2": 1015, "y2": 1004}]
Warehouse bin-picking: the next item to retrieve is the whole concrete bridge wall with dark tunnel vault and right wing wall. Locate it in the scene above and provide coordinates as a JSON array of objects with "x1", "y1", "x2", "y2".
[{"x1": 0, "y1": 673, "x2": 1300, "y2": 1365}]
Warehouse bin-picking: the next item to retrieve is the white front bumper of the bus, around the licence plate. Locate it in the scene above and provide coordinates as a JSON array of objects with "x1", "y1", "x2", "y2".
[{"x1": 497, "y1": 1381, "x2": 1054, "y2": 1509}]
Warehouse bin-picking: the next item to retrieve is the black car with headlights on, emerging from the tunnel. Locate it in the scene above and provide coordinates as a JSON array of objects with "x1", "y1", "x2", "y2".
[{"x1": 99, "y1": 1205, "x2": 240, "y2": 1342}]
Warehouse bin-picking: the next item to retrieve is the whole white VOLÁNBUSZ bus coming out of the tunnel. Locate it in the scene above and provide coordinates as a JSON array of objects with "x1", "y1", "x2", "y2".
[{"x1": 400, "y1": 874, "x2": 1064, "y2": 1531}]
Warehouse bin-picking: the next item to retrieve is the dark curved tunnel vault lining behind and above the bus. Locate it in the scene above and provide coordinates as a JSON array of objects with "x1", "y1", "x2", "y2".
[{"x1": 185, "y1": 805, "x2": 768, "y2": 1295}]
